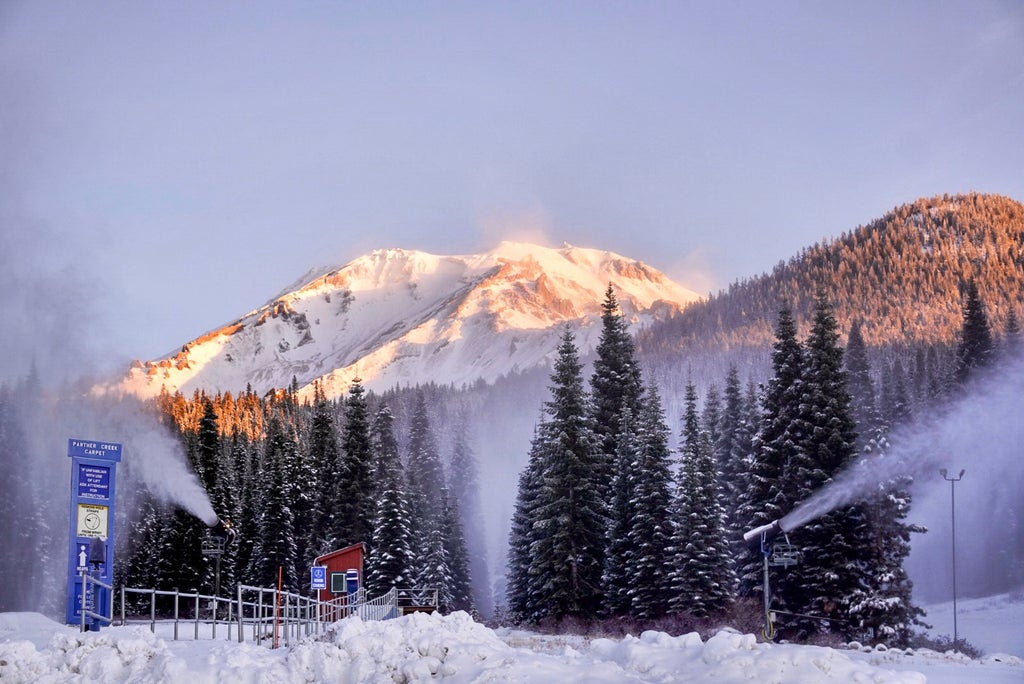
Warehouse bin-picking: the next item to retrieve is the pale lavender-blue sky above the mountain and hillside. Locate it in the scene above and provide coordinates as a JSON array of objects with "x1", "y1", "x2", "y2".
[{"x1": 0, "y1": 0, "x2": 1024, "y2": 376}]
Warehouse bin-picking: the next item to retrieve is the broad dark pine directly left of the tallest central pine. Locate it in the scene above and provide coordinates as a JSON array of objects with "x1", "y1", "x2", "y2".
[{"x1": 529, "y1": 329, "x2": 607, "y2": 618}]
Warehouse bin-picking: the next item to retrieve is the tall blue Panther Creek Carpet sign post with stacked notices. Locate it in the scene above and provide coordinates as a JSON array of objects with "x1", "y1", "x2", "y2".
[{"x1": 66, "y1": 439, "x2": 121, "y2": 630}]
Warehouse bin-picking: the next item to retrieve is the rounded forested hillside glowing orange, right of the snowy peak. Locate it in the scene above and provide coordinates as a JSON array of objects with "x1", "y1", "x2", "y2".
[{"x1": 638, "y1": 194, "x2": 1024, "y2": 386}]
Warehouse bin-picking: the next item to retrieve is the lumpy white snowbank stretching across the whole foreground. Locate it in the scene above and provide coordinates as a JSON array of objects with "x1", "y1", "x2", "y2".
[{"x1": 0, "y1": 613, "x2": 1024, "y2": 684}]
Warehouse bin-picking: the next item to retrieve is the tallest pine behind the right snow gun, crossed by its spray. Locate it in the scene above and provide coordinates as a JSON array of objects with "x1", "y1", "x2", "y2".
[{"x1": 778, "y1": 293, "x2": 868, "y2": 637}]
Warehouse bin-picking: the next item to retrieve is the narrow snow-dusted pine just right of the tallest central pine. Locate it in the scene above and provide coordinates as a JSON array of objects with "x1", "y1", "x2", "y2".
[{"x1": 629, "y1": 382, "x2": 672, "y2": 618}]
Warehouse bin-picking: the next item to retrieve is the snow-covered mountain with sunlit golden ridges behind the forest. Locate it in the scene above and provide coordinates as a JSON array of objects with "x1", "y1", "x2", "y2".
[{"x1": 119, "y1": 242, "x2": 699, "y2": 396}]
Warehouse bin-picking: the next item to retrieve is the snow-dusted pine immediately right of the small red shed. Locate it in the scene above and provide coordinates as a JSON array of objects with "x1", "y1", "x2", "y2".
[{"x1": 367, "y1": 405, "x2": 413, "y2": 596}]
